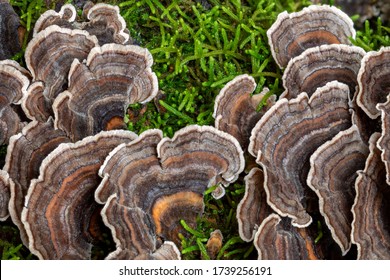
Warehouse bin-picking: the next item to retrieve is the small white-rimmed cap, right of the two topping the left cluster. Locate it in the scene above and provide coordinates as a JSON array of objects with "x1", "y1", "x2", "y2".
[{"x1": 82, "y1": 3, "x2": 130, "y2": 45}]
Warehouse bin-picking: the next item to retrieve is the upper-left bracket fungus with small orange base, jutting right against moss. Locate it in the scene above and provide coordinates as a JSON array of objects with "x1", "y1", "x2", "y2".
[{"x1": 53, "y1": 44, "x2": 158, "y2": 141}]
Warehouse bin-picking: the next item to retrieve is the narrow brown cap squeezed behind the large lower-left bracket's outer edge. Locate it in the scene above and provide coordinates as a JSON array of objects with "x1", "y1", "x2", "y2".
[{"x1": 4, "y1": 118, "x2": 70, "y2": 246}]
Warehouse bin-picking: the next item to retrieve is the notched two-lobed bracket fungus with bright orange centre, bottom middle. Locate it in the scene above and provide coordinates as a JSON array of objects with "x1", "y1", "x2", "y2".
[{"x1": 95, "y1": 125, "x2": 244, "y2": 254}]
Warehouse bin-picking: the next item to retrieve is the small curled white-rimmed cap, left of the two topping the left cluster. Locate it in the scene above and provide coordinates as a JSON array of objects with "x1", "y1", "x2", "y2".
[{"x1": 33, "y1": 4, "x2": 77, "y2": 36}]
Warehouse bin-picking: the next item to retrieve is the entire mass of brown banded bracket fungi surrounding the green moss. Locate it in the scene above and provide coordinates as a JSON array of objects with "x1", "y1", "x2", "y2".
[{"x1": 0, "y1": 0, "x2": 390, "y2": 259}]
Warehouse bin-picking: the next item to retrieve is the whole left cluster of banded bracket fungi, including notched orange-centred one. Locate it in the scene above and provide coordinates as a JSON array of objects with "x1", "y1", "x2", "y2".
[{"x1": 0, "y1": 4, "x2": 244, "y2": 259}]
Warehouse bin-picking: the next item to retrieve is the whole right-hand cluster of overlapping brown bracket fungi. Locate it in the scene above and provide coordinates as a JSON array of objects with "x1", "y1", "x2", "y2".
[{"x1": 214, "y1": 5, "x2": 390, "y2": 259}]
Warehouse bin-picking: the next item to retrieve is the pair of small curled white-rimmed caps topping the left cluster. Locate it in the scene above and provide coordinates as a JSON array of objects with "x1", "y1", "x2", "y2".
[{"x1": 34, "y1": 3, "x2": 130, "y2": 45}]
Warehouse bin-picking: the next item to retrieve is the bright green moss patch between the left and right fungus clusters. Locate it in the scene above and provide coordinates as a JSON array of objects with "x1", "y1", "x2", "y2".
[{"x1": 118, "y1": 0, "x2": 309, "y2": 136}]
